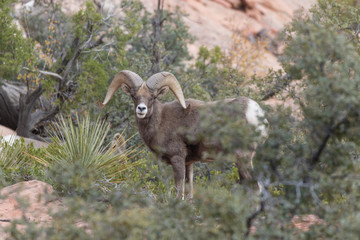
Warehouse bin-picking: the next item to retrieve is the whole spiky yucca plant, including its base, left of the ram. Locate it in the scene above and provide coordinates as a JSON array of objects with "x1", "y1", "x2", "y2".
[{"x1": 35, "y1": 116, "x2": 140, "y2": 192}]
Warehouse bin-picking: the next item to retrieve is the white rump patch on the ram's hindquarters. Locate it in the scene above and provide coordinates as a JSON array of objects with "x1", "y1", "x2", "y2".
[{"x1": 245, "y1": 99, "x2": 268, "y2": 137}]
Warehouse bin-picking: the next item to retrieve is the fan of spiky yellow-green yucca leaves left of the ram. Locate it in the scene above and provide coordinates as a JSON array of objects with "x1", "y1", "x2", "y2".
[{"x1": 46, "y1": 116, "x2": 139, "y2": 182}]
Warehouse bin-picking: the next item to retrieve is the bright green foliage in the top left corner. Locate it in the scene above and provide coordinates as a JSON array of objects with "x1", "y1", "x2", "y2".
[{"x1": 0, "y1": 0, "x2": 33, "y2": 80}]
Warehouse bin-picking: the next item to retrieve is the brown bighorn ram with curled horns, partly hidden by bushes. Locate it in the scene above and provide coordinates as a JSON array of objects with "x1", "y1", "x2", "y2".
[{"x1": 100, "y1": 70, "x2": 267, "y2": 199}]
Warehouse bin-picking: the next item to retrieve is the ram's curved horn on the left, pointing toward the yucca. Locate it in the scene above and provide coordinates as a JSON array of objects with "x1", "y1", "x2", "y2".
[{"x1": 100, "y1": 70, "x2": 144, "y2": 107}]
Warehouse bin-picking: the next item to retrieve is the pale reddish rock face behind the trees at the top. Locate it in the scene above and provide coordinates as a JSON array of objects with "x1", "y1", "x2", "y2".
[{"x1": 43, "y1": 0, "x2": 316, "y2": 72}]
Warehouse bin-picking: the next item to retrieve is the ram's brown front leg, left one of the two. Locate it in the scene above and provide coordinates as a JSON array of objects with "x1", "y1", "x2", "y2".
[{"x1": 170, "y1": 156, "x2": 185, "y2": 200}]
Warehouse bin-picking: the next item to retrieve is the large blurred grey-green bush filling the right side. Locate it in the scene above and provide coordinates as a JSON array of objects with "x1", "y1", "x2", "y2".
[{"x1": 249, "y1": 1, "x2": 360, "y2": 239}]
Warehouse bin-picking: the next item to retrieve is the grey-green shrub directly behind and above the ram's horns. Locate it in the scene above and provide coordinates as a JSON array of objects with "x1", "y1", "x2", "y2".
[{"x1": 118, "y1": 1, "x2": 194, "y2": 77}]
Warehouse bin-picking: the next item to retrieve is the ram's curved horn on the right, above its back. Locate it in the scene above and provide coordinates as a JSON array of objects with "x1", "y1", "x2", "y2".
[{"x1": 146, "y1": 72, "x2": 186, "y2": 109}]
